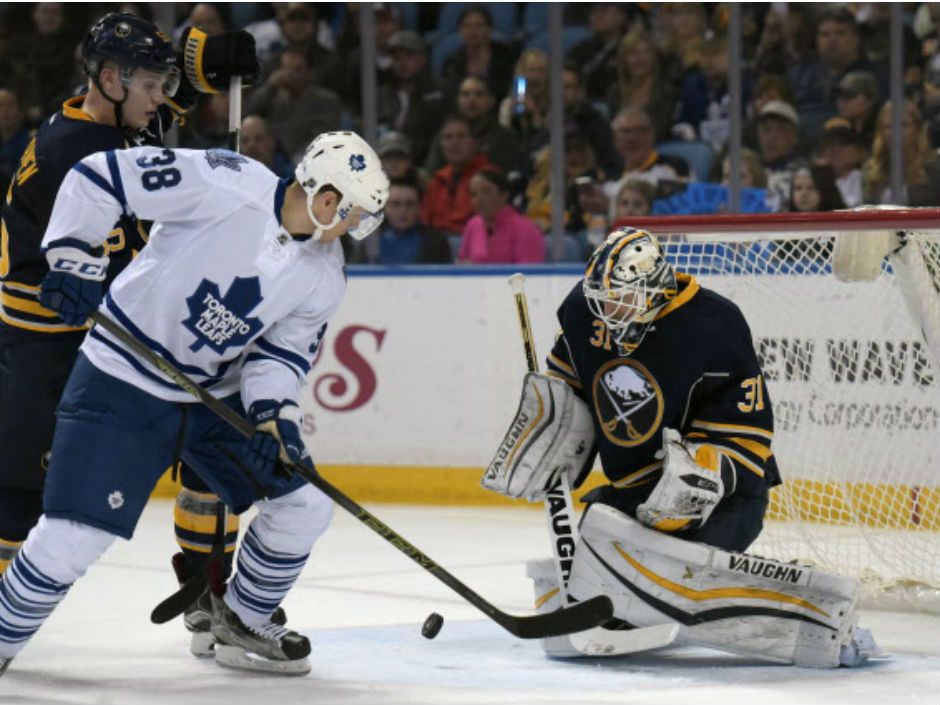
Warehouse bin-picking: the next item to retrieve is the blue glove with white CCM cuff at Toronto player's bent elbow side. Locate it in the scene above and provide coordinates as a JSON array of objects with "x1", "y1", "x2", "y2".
[{"x1": 39, "y1": 243, "x2": 108, "y2": 328}]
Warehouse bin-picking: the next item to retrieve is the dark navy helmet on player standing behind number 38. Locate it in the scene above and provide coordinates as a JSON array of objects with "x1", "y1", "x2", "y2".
[{"x1": 82, "y1": 12, "x2": 180, "y2": 96}]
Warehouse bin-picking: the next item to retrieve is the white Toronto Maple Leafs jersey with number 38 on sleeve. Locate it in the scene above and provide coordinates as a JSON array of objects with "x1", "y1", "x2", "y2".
[{"x1": 43, "y1": 147, "x2": 346, "y2": 409}]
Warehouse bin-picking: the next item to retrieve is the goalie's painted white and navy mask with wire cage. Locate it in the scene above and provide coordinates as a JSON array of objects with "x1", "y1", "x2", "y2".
[{"x1": 582, "y1": 227, "x2": 676, "y2": 347}]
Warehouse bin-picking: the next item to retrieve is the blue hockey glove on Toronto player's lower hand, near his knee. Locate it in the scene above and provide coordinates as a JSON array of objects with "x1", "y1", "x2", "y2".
[{"x1": 247, "y1": 399, "x2": 314, "y2": 476}]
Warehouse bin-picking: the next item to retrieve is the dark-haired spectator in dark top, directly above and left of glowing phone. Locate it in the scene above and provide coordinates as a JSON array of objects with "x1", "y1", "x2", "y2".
[{"x1": 443, "y1": 5, "x2": 515, "y2": 100}]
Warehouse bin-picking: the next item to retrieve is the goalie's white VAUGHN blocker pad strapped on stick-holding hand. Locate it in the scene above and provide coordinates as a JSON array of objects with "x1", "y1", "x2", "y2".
[{"x1": 480, "y1": 372, "x2": 595, "y2": 502}]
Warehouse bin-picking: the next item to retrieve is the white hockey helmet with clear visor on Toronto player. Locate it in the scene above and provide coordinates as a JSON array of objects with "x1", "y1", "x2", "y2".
[{"x1": 294, "y1": 132, "x2": 388, "y2": 240}]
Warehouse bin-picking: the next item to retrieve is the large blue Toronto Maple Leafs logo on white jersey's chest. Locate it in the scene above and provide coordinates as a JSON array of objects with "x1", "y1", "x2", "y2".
[{"x1": 182, "y1": 277, "x2": 261, "y2": 354}]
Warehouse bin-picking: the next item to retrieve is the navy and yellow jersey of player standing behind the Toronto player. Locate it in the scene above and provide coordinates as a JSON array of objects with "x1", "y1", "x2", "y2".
[{"x1": 0, "y1": 96, "x2": 171, "y2": 344}]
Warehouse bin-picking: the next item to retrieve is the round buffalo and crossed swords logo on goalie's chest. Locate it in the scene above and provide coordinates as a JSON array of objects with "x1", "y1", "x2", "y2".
[{"x1": 594, "y1": 358, "x2": 663, "y2": 448}]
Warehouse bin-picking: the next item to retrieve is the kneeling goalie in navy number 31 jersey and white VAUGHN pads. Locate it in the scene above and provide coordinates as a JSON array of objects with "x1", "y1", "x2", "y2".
[{"x1": 482, "y1": 228, "x2": 877, "y2": 668}]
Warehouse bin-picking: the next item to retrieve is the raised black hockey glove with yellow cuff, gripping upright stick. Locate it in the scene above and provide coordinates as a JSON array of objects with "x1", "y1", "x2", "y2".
[{"x1": 181, "y1": 27, "x2": 261, "y2": 93}]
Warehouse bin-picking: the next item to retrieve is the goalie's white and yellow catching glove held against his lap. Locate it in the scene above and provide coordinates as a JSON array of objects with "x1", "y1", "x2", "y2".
[{"x1": 636, "y1": 428, "x2": 736, "y2": 532}]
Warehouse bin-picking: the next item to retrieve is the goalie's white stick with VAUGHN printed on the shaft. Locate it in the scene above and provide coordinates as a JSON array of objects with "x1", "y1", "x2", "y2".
[{"x1": 509, "y1": 272, "x2": 679, "y2": 656}]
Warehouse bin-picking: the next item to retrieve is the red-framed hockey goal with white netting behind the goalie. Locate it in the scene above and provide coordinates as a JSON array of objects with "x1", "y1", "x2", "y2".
[{"x1": 618, "y1": 207, "x2": 940, "y2": 613}]
